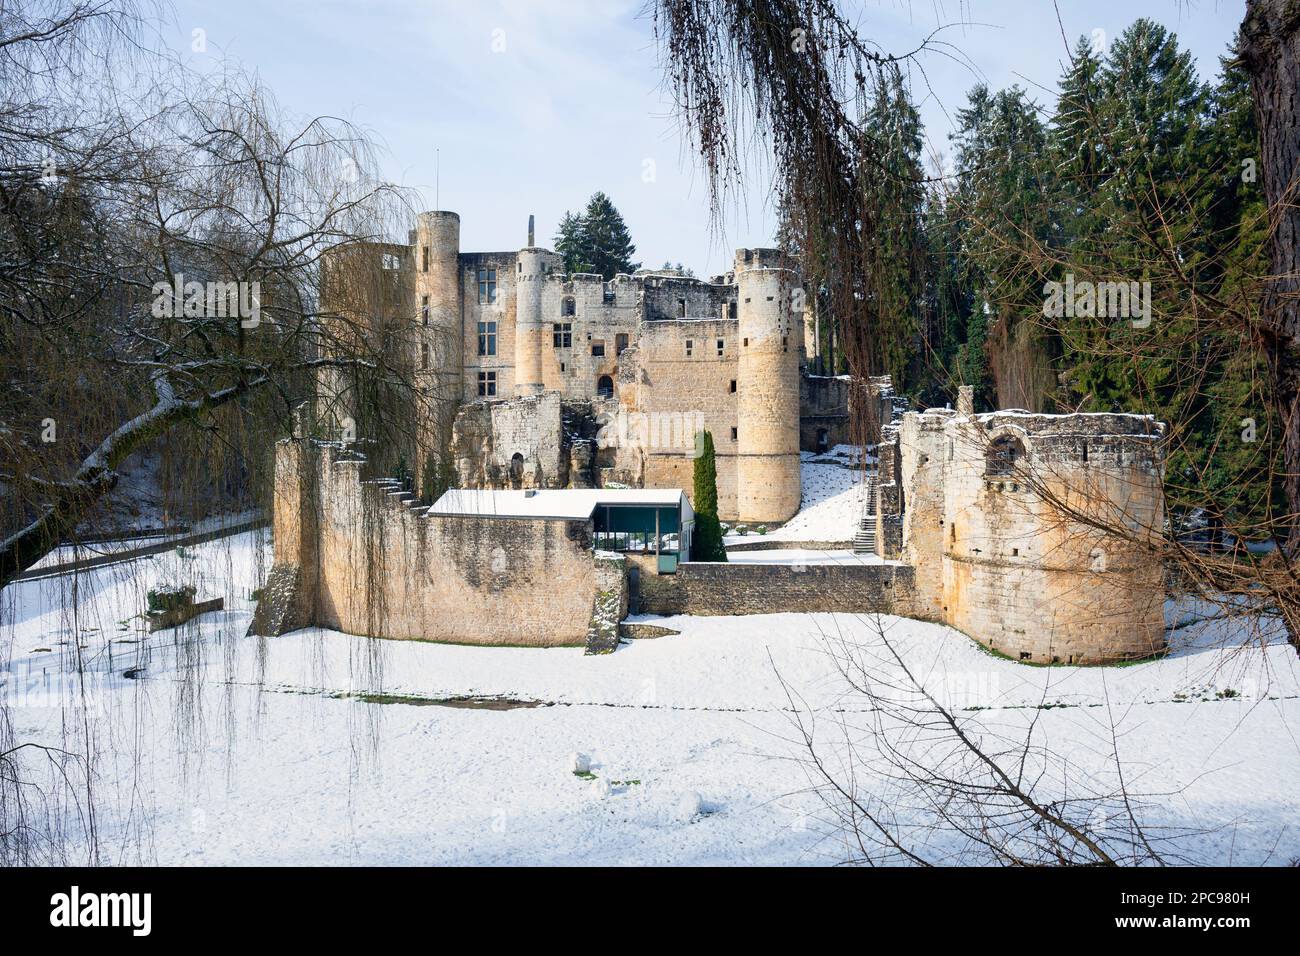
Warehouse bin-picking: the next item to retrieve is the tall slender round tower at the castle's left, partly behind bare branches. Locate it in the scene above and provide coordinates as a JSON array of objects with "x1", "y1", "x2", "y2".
[{"x1": 415, "y1": 211, "x2": 464, "y2": 486}]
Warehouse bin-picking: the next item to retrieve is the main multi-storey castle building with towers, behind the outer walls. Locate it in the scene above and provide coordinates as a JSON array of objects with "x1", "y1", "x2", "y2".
[{"x1": 321, "y1": 211, "x2": 849, "y2": 523}]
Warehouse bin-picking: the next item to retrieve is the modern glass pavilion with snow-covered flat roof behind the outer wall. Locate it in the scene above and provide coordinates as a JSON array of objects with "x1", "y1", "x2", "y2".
[{"x1": 429, "y1": 488, "x2": 696, "y2": 574}]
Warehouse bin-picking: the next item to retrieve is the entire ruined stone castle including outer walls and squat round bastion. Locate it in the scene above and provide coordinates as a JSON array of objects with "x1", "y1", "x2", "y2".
[{"x1": 254, "y1": 212, "x2": 1165, "y2": 665}]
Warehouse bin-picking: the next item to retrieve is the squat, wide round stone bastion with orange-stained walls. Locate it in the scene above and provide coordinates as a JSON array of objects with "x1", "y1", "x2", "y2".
[{"x1": 898, "y1": 410, "x2": 1164, "y2": 663}]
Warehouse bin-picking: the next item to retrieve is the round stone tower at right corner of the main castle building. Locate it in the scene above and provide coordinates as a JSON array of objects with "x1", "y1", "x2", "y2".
[{"x1": 736, "y1": 250, "x2": 801, "y2": 522}]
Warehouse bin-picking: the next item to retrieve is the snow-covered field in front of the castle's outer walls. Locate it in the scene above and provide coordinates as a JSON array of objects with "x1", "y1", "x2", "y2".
[{"x1": 3, "y1": 535, "x2": 1300, "y2": 865}]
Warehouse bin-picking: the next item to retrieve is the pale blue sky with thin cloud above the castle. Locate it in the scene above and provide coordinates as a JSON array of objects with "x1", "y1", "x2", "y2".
[{"x1": 170, "y1": 0, "x2": 1244, "y2": 276}]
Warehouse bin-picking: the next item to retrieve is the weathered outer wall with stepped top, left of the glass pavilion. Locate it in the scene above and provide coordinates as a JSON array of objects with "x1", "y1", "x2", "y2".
[{"x1": 271, "y1": 441, "x2": 610, "y2": 646}]
